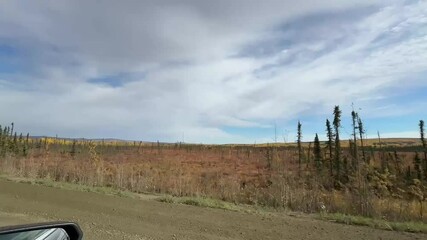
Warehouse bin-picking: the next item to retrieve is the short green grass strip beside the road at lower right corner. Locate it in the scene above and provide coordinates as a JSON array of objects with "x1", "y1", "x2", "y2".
[{"x1": 317, "y1": 213, "x2": 427, "y2": 233}]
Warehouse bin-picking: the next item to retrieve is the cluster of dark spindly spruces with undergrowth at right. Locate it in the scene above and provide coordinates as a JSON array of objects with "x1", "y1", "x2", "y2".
[{"x1": 297, "y1": 106, "x2": 427, "y2": 201}]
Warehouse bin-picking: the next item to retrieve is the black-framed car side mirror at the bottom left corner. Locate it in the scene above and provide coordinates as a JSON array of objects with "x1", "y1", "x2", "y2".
[{"x1": 0, "y1": 222, "x2": 83, "y2": 240}]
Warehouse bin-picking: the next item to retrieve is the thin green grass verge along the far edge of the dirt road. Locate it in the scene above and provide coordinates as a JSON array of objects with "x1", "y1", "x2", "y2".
[{"x1": 0, "y1": 174, "x2": 427, "y2": 233}]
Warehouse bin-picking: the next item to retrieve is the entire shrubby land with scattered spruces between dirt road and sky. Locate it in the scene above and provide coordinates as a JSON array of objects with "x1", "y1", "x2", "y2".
[{"x1": 0, "y1": 106, "x2": 427, "y2": 222}]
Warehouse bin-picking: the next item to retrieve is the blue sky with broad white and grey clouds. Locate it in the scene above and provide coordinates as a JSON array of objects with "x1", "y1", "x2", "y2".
[{"x1": 0, "y1": 0, "x2": 427, "y2": 143}]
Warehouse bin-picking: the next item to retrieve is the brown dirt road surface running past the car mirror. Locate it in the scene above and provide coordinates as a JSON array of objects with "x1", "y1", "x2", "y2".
[{"x1": 0, "y1": 180, "x2": 427, "y2": 240}]
